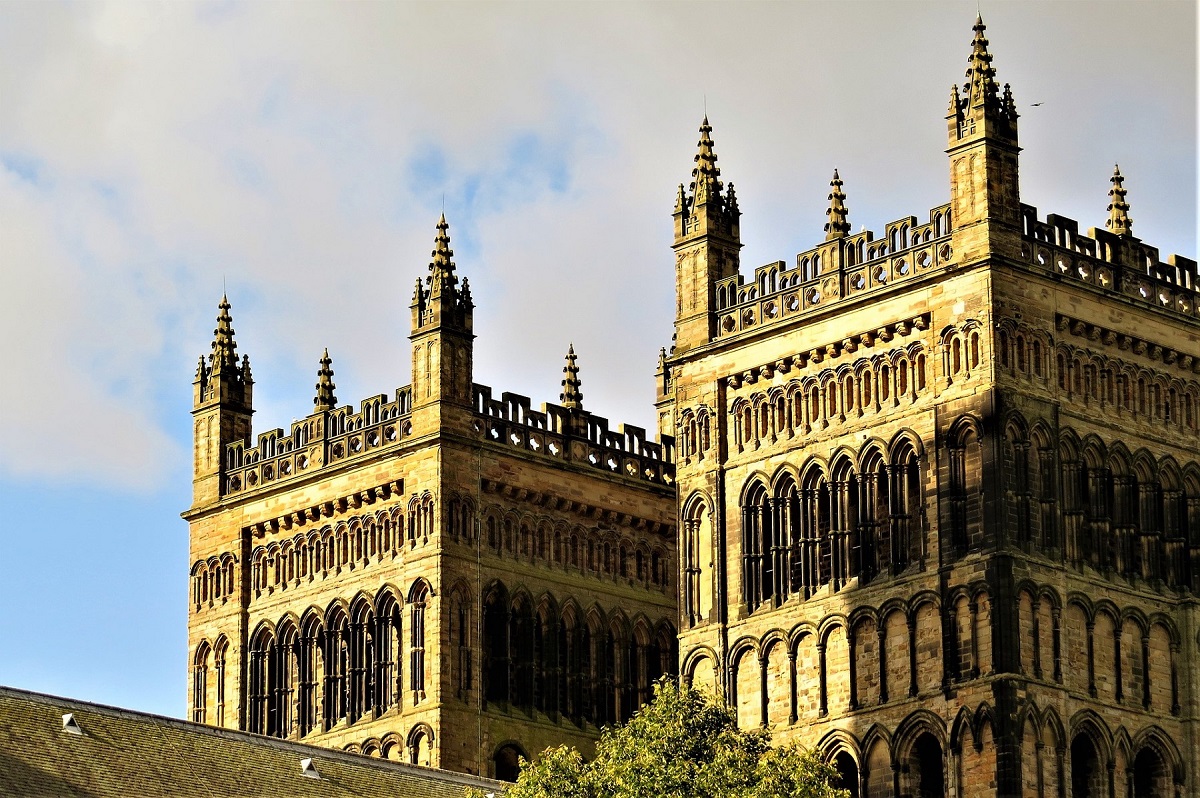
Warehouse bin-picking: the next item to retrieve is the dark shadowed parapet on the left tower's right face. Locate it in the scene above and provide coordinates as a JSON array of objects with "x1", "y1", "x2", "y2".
[{"x1": 474, "y1": 384, "x2": 674, "y2": 486}]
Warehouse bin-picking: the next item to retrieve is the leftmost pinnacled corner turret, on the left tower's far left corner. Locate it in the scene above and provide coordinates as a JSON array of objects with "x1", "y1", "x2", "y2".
[{"x1": 192, "y1": 295, "x2": 254, "y2": 506}]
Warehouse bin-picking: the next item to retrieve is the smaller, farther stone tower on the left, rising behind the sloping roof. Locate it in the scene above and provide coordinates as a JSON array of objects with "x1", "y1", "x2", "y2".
[{"x1": 184, "y1": 217, "x2": 678, "y2": 779}]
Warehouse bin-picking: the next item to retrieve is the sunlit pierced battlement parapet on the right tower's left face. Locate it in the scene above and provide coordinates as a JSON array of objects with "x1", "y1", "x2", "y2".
[{"x1": 716, "y1": 204, "x2": 954, "y2": 338}]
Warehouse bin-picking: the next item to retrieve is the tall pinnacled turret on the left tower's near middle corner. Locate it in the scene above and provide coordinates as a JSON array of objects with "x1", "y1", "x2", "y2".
[{"x1": 408, "y1": 214, "x2": 475, "y2": 420}]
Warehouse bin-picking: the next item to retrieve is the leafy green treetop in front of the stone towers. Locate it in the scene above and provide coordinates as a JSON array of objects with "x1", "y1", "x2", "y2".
[{"x1": 472, "y1": 679, "x2": 850, "y2": 798}]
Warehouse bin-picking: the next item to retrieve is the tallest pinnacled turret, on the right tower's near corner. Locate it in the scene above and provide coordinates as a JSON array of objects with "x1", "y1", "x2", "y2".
[{"x1": 946, "y1": 17, "x2": 1021, "y2": 264}]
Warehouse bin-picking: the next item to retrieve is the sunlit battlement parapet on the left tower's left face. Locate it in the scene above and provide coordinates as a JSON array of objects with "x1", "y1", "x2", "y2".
[{"x1": 223, "y1": 385, "x2": 413, "y2": 494}]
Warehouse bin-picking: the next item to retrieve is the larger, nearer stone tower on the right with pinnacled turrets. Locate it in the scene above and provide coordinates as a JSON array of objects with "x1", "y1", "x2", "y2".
[{"x1": 659, "y1": 20, "x2": 1200, "y2": 798}]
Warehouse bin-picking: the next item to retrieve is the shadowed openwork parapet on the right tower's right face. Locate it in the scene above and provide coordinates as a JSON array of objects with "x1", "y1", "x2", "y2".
[{"x1": 1021, "y1": 205, "x2": 1200, "y2": 319}]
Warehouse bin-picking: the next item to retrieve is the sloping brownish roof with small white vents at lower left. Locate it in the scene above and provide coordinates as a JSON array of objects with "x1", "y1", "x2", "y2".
[{"x1": 0, "y1": 688, "x2": 504, "y2": 798}]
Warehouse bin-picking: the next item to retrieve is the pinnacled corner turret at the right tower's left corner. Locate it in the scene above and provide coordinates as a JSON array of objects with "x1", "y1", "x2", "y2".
[{"x1": 672, "y1": 116, "x2": 742, "y2": 352}]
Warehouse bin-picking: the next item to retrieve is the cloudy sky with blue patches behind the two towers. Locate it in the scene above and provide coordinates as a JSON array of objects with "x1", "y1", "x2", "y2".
[{"x1": 0, "y1": 0, "x2": 1196, "y2": 715}]
